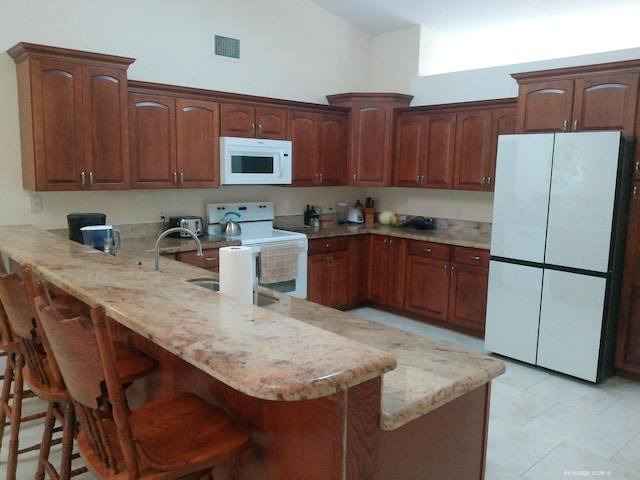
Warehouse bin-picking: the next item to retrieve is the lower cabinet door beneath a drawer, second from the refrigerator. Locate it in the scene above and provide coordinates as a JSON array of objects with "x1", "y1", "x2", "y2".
[{"x1": 404, "y1": 255, "x2": 449, "y2": 321}]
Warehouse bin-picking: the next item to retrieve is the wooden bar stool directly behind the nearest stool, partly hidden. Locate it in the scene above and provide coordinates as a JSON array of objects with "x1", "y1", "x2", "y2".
[{"x1": 0, "y1": 265, "x2": 155, "y2": 480}]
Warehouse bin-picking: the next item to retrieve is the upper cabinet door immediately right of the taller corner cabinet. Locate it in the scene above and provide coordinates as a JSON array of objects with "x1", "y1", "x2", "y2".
[{"x1": 394, "y1": 115, "x2": 426, "y2": 187}]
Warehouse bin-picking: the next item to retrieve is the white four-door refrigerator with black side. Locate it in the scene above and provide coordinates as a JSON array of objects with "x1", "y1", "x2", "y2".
[{"x1": 485, "y1": 132, "x2": 634, "y2": 382}]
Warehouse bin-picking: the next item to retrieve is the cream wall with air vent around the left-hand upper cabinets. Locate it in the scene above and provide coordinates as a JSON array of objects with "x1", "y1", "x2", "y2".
[{"x1": 0, "y1": 0, "x2": 371, "y2": 227}]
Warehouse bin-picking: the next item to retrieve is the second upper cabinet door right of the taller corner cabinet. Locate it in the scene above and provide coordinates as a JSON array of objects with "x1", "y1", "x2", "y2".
[{"x1": 422, "y1": 113, "x2": 456, "y2": 188}]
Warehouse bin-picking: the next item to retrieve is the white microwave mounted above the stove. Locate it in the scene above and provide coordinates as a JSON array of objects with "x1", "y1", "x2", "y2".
[{"x1": 220, "y1": 137, "x2": 292, "y2": 185}]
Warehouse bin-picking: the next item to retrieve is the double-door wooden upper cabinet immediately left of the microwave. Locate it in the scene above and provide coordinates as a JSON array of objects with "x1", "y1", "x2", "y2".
[{"x1": 129, "y1": 88, "x2": 220, "y2": 188}]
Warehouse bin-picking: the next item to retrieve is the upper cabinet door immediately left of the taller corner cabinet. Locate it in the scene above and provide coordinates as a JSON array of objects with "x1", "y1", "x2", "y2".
[{"x1": 316, "y1": 115, "x2": 346, "y2": 186}]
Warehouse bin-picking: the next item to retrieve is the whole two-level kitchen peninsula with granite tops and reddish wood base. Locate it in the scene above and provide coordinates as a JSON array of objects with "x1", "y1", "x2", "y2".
[{"x1": 0, "y1": 226, "x2": 504, "y2": 480}]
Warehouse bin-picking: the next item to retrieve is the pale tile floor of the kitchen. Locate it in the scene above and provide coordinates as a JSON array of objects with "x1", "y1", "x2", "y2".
[{"x1": 0, "y1": 308, "x2": 640, "y2": 480}]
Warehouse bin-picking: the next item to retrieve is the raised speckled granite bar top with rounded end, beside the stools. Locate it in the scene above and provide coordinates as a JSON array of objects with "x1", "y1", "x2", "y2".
[{"x1": 0, "y1": 226, "x2": 396, "y2": 400}]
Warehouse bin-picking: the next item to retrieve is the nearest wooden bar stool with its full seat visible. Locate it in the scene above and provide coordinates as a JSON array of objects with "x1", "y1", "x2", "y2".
[{"x1": 35, "y1": 298, "x2": 250, "y2": 480}]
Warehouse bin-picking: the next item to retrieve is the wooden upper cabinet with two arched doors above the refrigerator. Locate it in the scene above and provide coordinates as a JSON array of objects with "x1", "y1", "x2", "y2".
[{"x1": 512, "y1": 60, "x2": 640, "y2": 135}]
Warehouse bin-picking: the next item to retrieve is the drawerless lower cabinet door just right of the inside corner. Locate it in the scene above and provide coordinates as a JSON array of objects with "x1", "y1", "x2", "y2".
[{"x1": 367, "y1": 235, "x2": 407, "y2": 308}]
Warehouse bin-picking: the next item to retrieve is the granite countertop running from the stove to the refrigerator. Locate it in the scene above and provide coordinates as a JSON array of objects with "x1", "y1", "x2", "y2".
[{"x1": 275, "y1": 220, "x2": 491, "y2": 250}]
